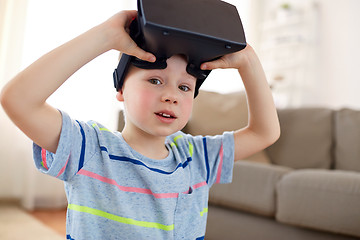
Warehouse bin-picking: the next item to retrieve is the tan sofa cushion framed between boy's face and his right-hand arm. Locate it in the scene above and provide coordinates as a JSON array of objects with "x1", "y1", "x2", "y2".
[{"x1": 183, "y1": 91, "x2": 270, "y2": 163}]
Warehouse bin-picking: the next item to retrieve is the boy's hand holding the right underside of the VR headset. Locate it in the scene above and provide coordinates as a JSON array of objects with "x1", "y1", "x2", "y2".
[{"x1": 201, "y1": 44, "x2": 254, "y2": 70}]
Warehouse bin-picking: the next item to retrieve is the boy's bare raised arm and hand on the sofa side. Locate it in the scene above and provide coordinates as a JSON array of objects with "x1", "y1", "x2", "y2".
[{"x1": 202, "y1": 45, "x2": 280, "y2": 160}]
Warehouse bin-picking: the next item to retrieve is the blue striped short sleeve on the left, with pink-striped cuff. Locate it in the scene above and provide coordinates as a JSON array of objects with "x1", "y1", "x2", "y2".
[{"x1": 33, "y1": 111, "x2": 97, "y2": 181}]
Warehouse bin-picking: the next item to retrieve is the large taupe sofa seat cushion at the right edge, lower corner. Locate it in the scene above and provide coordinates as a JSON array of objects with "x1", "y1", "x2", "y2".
[{"x1": 276, "y1": 169, "x2": 360, "y2": 237}]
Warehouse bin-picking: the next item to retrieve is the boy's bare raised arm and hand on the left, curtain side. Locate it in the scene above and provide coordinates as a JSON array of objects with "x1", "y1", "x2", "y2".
[{"x1": 0, "y1": 11, "x2": 155, "y2": 152}]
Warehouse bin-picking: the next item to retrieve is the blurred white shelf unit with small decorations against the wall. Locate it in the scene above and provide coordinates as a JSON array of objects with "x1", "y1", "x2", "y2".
[{"x1": 259, "y1": 0, "x2": 319, "y2": 108}]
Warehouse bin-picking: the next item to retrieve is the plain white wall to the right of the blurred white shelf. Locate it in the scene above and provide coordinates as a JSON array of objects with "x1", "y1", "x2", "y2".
[{"x1": 313, "y1": 0, "x2": 360, "y2": 109}]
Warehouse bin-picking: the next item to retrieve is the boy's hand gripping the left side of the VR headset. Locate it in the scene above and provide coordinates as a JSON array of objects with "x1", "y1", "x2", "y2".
[{"x1": 104, "y1": 10, "x2": 156, "y2": 62}]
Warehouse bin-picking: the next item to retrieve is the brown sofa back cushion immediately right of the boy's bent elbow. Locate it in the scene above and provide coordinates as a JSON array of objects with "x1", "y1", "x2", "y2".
[{"x1": 266, "y1": 108, "x2": 333, "y2": 169}]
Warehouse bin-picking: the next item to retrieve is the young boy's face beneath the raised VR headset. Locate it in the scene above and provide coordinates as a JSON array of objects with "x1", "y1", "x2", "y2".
[{"x1": 117, "y1": 55, "x2": 196, "y2": 137}]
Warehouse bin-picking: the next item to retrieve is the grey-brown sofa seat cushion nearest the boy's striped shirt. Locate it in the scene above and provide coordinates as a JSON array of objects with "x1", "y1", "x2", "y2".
[{"x1": 210, "y1": 161, "x2": 290, "y2": 216}]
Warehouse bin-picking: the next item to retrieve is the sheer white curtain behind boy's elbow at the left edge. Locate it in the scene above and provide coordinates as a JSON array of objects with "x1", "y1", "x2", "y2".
[{"x1": 0, "y1": 0, "x2": 66, "y2": 209}]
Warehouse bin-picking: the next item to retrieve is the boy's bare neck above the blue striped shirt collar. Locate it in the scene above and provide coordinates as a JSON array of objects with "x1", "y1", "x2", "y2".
[{"x1": 121, "y1": 129, "x2": 169, "y2": 160}]
